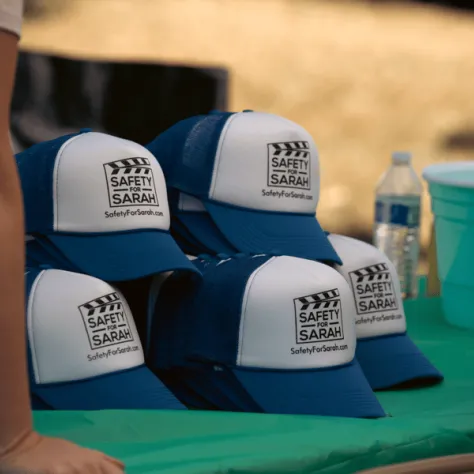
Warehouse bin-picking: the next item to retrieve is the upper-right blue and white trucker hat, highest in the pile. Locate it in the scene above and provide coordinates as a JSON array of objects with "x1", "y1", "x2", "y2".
[{"x1": 147, "y1": 111, "x2": 341, "y2": 263}]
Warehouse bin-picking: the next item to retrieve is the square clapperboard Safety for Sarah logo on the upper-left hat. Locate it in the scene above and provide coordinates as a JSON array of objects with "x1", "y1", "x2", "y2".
[{"x1": 104, "y1": 158, "x2": 159, "y2": 207}]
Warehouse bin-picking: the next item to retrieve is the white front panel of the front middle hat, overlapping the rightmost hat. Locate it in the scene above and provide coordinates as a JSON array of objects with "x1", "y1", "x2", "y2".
[{"x1": 237, "y1": 257, "x2": 356, "y2": 369}]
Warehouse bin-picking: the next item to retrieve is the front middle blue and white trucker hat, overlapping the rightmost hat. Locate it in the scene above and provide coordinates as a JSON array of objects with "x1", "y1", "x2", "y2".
[{"x1": 149, "y1": 255, "x2": 384, "y2": 417}]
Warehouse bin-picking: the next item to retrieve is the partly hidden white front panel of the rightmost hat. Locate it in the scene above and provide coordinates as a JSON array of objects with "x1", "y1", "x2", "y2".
[{"x1": 329, "y1": 234, "x2": 406, "y2": 338}]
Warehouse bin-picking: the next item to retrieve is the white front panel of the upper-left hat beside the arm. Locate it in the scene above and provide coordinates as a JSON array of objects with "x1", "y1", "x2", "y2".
[{"x1": 54, "y1": 132, "x2": 170, "y2": 233}]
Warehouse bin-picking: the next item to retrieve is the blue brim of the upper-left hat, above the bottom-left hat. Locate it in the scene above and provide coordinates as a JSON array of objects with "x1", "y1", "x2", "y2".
[{"x1": 47, "y1": 231, "x2": 199, "y2": 281}]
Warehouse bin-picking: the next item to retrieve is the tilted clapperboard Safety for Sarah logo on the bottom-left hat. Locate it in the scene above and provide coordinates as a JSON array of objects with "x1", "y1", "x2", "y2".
[{"x1": 79, "y1": 293, "x2": 134, "y2": 349}]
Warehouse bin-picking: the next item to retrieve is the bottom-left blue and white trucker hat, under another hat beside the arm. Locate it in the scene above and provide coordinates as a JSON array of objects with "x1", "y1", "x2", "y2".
[{"x1": 26, "y1": 269, "x2": 184, "y2": 410}]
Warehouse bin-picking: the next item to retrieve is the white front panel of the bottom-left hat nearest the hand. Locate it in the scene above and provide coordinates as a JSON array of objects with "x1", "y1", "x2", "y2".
[{"x1": 27, "y1": 270, "x2": 144, "y2": 384}]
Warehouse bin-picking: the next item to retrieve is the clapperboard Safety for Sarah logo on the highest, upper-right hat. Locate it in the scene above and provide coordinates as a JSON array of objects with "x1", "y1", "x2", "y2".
[{"x1": 267, "y1": 142, "x2": 311, "y2": 189}]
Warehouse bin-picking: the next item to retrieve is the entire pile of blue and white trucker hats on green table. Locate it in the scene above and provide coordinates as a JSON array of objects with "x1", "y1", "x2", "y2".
[{"x1": 16, "y1": 111, "x2": 443, "y2": 418}]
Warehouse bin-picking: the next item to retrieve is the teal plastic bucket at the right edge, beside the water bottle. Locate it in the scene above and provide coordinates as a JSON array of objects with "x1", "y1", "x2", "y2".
[{"x1": 423, "y1": 161, "x2": 474, "y2": 329}]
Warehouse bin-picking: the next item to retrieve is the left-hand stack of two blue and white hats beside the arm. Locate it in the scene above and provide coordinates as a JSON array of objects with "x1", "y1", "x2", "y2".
[{"x1": 16, "y1": 130, "x2": 200, "y2": 410}]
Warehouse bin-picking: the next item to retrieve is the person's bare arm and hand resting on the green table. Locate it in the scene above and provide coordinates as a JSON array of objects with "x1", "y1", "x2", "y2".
[{"x1": 0, "y1": 20, "x2": 124, "y2": 474}]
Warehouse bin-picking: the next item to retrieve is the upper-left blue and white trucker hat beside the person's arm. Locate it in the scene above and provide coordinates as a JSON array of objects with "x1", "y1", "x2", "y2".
[{"x1": 16, "y1": 131, "x2": 196, "y2": 281}]
